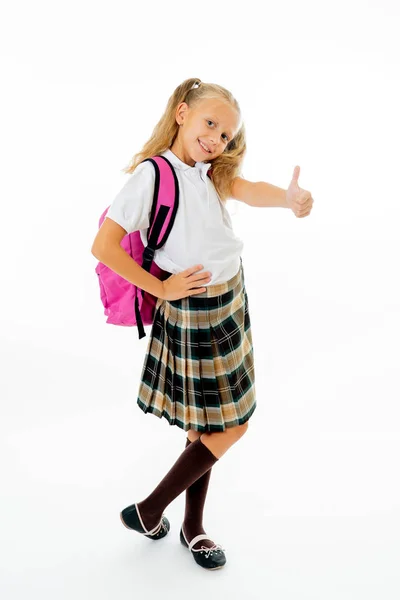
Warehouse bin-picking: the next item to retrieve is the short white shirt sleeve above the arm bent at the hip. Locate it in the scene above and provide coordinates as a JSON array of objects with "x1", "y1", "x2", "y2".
[{"x1": 105, "y1": 161, "x2": 155, "y2": 233}]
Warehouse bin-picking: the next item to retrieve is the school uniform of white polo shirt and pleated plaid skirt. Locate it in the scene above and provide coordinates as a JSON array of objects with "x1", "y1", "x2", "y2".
[{"x1": 106, "y1": 149, "x2": 256, "y2": 432}]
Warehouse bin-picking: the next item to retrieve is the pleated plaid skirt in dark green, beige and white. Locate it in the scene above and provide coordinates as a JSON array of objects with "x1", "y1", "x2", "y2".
[{"x1": 137, "y1": 259, "x2": 256, "y2": 432}]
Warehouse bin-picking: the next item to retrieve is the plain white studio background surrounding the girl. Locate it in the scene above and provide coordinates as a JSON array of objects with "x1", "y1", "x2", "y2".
[{"x1": 0, "y1": 0, "x2": 400, "y2": 600}]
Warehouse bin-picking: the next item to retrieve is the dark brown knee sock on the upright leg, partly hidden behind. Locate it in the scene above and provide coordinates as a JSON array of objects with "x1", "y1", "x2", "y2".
[{"x1": 183, "y1": 438, "x2": 213, "y2": 550}]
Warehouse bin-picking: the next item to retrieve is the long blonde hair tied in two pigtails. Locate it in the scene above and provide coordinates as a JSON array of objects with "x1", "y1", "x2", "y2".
[{"x1": 123, "y1": 78, "x2": 246, "y2": 203}]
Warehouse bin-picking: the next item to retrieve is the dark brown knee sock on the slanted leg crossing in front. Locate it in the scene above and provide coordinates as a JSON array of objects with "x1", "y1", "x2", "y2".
[{"x1": 137, "y1": 438, "x2": 218, "y2": 530}]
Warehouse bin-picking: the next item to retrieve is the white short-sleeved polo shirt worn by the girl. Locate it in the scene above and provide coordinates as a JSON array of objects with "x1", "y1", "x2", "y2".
[{"x1": 106, "y1": 149, "x2": 243, "y2": 286}]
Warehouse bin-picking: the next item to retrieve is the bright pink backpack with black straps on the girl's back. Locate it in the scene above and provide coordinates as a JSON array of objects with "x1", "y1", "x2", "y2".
[{"x1": 95, "y1": 156, "x2": 179, "y2": 339}]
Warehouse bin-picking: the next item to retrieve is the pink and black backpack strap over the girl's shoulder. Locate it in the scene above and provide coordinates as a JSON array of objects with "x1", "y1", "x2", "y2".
[{"x1": 135, "y1": 156, "x2": 179, "y2": 339}]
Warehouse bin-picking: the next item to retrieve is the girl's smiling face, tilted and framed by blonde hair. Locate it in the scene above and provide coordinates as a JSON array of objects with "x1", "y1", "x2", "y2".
[{"x1": 171, "y1": 98, "x2": 240, "y2": 166}]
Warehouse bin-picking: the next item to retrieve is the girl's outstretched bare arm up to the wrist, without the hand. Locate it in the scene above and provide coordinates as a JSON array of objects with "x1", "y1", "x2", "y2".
[{"x1": 231, "y1": 177, "x2": 289, "y2": 208}]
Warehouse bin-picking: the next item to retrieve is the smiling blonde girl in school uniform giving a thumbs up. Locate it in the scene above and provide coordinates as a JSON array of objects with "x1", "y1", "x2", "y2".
[{"x1": 92, "y1": 79, "x2": 312, "y2": 569}]
